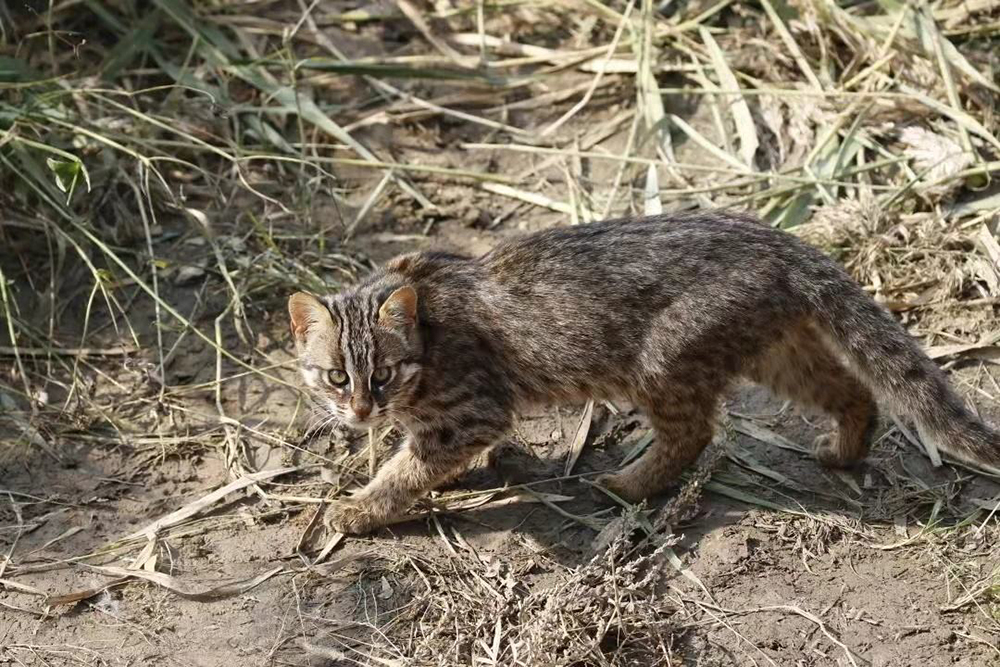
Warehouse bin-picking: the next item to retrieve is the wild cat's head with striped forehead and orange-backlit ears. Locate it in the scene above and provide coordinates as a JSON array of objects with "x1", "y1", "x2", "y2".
[{"x1": 288, "y1": 285, "x2": 421, "y2": 430}]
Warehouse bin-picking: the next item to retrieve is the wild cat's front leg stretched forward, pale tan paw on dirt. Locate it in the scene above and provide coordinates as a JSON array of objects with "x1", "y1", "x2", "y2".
[{"x1": 324, "y1": 430, "x2": 494, "y2": 535}]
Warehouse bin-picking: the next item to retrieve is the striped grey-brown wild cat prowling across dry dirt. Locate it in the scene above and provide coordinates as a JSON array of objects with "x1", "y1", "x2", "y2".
[{"x1": 288, "y1": 212, "x2": 1000, "y2": 533}]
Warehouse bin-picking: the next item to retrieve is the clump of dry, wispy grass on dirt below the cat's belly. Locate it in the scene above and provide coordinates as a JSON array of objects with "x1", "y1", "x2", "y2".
[{"x1": 305, "y1": 512, "x2": 677, "y2": 666}]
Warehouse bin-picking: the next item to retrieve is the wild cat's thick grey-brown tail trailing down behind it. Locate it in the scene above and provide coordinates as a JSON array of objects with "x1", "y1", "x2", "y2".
[{"x1": 805, "y1": 267, "x2": 1000, "y2": 474}]
